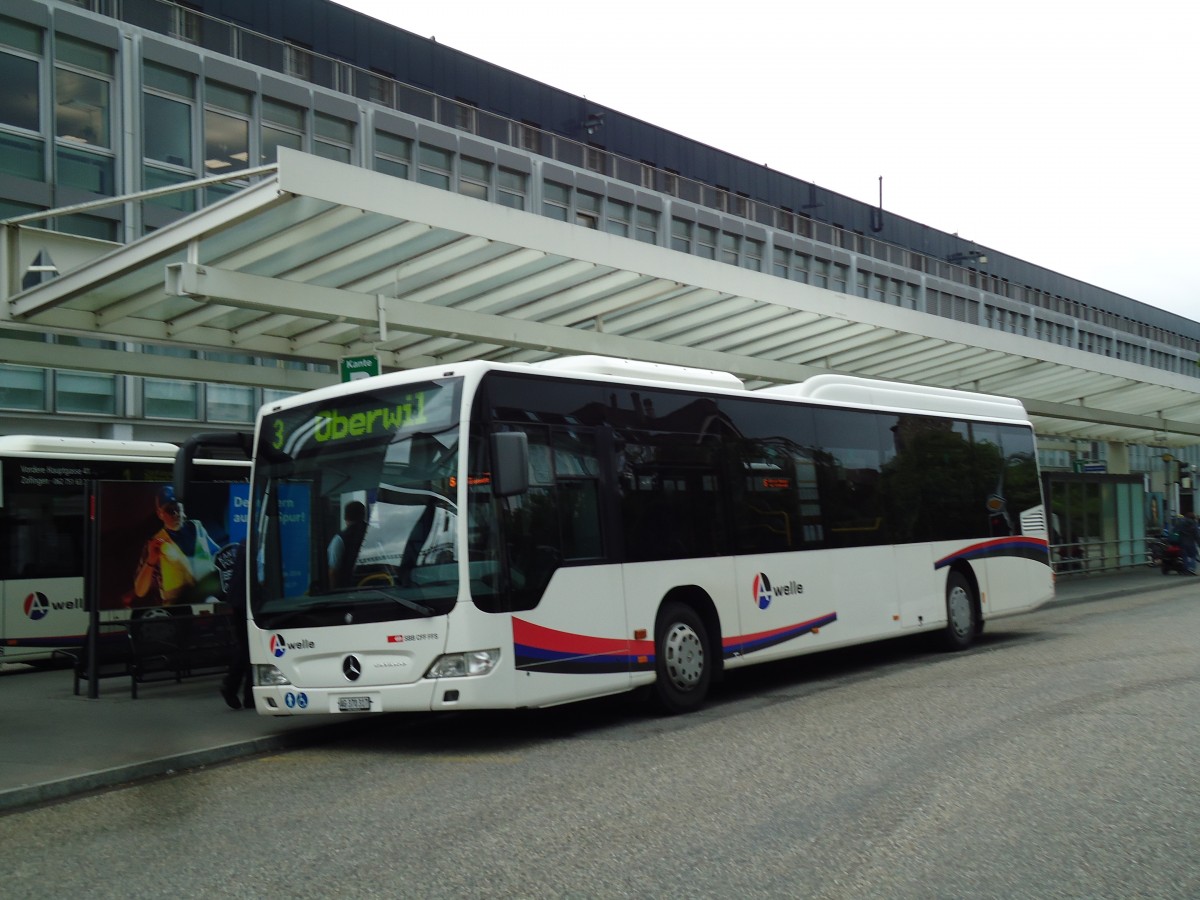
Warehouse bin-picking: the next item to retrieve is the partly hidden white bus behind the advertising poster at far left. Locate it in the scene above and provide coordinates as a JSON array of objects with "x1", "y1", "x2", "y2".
[{"x1": 0, "y1": 434, "x2": 247, "y2": 662}]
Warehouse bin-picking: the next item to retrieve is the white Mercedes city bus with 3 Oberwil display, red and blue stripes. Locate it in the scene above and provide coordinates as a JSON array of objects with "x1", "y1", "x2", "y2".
[{"x1": 194, "y1": 356, "x2": 1054, "y2": 715}]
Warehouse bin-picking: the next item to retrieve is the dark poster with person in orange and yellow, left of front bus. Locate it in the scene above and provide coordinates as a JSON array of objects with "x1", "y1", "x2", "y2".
[{"x1": 95, "y1": 481, "x2": 248, "y2": 610}]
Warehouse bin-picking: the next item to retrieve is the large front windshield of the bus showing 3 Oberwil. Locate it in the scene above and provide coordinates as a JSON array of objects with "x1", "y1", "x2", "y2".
[{"x1": 250, "y1": 378, "x2": 462, "y2": 629}]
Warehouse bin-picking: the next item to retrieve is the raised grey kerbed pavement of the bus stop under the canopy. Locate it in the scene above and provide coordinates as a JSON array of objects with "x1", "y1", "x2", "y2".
[{"x1": 0, "y1": 569, "x2": 1180, "y2": 815}]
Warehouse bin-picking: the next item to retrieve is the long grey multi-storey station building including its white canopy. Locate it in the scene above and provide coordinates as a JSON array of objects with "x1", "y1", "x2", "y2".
[{"x1": 0, "y1": 0, "x2": 1200, "y2": 568}]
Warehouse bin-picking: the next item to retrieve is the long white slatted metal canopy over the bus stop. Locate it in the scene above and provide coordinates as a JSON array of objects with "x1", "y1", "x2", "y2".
[{"x1": 7, "y1": 150, "x2": 1200, "y2": 446}]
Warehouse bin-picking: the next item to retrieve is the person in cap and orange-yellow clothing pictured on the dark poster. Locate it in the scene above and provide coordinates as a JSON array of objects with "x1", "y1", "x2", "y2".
[{"x1": 133, "y1": 485, "x2": 220, "y2": 606}]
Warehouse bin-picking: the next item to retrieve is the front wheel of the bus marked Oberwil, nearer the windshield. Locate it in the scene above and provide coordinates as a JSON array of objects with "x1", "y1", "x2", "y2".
[{"x1": 652, "y1": 602, "x2": 713, "y2": 715}]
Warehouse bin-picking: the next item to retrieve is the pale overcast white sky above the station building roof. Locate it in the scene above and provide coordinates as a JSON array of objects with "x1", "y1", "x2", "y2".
[{"x1": 338, "y1": 0, "x2": 1200, "y2": 320}]
